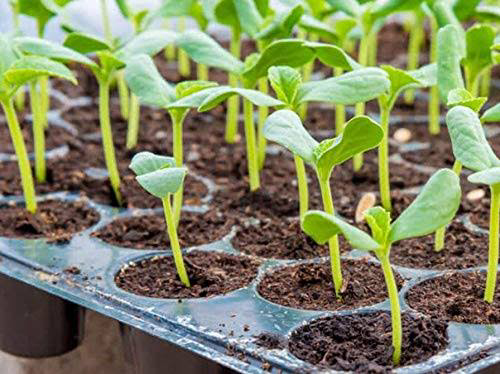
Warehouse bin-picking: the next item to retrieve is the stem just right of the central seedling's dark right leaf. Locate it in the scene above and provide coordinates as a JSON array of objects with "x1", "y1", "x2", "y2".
[{"x1": 378, "y1": 105, "x2": 392, "y2": 212}]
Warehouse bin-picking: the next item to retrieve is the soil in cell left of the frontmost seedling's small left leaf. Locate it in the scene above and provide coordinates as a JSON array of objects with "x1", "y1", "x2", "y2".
[{"x1": 231, "y1": 219, "x2": 332, "y2": 260}]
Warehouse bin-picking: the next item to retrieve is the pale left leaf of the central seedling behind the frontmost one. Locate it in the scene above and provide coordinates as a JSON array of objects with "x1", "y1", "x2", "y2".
[{"x1": 263, "y1": 109, "x2": 318, "y2": 164}]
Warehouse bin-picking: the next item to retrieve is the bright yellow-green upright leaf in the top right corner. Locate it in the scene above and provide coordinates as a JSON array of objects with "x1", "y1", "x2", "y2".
[{"x1": 463, "y1": 25, "x2": 495, "y2": 90}]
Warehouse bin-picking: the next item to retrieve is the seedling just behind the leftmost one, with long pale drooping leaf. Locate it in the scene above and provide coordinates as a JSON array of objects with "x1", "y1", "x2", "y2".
[{"x1": 13, "y1": 37, "x2": 96, "y2": 183}]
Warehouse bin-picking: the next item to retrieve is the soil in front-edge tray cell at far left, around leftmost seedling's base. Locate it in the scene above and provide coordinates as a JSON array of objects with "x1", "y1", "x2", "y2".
[{"x1": 0, "y1": 200, "x2": 99, "y2": 241}]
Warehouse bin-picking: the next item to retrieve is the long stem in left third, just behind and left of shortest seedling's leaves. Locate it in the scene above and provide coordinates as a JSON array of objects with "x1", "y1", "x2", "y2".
[{"x1": 98, "y1": 77, "x2": 122, "y2": 206}]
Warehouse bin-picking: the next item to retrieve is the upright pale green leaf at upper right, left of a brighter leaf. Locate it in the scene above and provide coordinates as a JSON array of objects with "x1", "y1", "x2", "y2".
[{"x1": 437, "y1": 25, "x2": 464, "y2": 101}]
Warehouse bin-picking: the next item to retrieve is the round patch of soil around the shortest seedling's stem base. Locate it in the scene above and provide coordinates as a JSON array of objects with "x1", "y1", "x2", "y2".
[{"x1": 115, "y1": 251, "x2": 259, "y2": 299}]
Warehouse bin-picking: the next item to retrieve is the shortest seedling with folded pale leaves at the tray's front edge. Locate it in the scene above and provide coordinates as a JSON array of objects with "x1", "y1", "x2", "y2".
[{"x1": 130, "y1": 152, "x2": 191, "y2": 287}]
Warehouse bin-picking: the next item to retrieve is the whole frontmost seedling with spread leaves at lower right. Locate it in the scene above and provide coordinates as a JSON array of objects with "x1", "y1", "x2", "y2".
[{"x1": 302, "y1": 169, "x2": 461, "y2": 366}]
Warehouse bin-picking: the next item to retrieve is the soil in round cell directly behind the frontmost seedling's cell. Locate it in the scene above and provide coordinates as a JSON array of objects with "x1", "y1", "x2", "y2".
[{"x1": 257, "y1": 259, "x2": 403, "y2": 310}]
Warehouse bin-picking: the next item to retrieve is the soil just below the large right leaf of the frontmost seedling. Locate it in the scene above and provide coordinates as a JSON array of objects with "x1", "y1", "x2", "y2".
[{"x1": 391, "y1": 221, "x2": 488, "y2": 270}]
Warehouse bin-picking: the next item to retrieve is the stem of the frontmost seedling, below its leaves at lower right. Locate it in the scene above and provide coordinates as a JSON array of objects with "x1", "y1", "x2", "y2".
[{"x1": 379, "y1": 250, "x2": 403, "y2": 366}]
